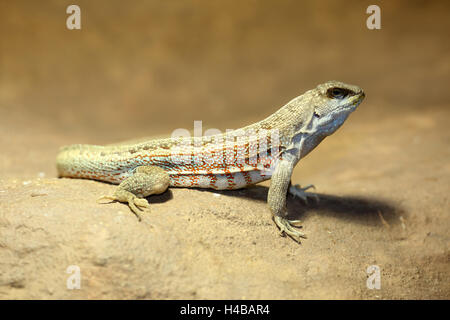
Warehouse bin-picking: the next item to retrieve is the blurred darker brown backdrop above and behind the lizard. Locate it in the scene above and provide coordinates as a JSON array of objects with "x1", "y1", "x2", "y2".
[{"x1": 0, "y1": 0, "x2": 450, "y2": 143}]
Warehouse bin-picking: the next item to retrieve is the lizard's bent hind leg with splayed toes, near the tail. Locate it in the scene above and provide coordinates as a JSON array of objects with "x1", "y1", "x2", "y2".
[{"x1": 98, "y1": 166, "x2": 170, "y2": 221}]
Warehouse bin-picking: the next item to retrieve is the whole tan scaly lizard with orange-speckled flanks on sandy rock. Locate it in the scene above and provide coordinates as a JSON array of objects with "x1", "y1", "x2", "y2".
[{"x1": 56, "y1": 81, "x2": 365, "y2": 243}]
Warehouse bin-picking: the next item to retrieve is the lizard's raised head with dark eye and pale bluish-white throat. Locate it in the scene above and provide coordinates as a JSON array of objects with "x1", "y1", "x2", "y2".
[{"x1": 310, "y1": 81, "x2": 365, "y2": 136}]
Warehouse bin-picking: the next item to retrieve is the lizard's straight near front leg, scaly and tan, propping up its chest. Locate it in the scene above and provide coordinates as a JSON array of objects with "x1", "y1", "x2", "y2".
[{"x1": 267, "y1": 159, "x2": 306, "y2": 243}]
